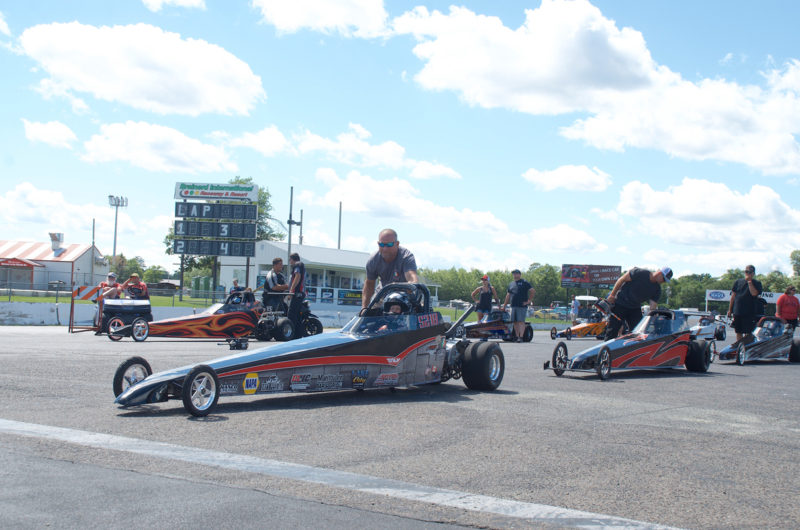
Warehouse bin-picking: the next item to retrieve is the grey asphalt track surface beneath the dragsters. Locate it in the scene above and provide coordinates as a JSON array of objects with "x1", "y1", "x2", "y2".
[{"x1": 0, "y1": 327, "x2": 800, "y2": 528}]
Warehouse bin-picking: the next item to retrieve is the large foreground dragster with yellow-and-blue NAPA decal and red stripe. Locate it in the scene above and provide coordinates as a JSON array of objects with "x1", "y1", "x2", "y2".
[{"x1": 113, "y1": 283, "x2": 505, "y2": 416}]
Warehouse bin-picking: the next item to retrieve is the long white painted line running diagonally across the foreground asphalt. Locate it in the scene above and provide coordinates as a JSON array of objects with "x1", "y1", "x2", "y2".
[{"x1": 0, "y1": 418, "x2": 668, "y2": 529}]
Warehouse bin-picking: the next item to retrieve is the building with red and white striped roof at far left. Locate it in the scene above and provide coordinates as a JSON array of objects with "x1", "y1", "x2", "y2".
[{"x1": 0, "y1": 234, "x2": 109, "y2": 290}]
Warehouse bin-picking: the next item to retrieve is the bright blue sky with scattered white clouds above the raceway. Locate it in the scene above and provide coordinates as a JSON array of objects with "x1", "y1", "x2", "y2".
[{"x1": 0, "y1": 0, "x2": 800, "y2": 275}]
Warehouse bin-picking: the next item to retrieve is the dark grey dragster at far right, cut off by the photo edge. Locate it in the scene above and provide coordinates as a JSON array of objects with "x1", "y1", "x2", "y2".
[{"x1": 718, "y1": 317, "x2": 800, "y2": 366}]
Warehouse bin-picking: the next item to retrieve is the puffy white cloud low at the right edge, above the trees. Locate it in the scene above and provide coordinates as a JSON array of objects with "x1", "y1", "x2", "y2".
[{"x1": 617, "y1": 178, "x2": 800, "y2": 256}]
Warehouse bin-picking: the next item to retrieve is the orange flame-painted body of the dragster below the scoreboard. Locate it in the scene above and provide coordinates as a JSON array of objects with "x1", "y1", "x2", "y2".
[{"x1": 150, "y1": 311, "x2": 258, "y2": 338}]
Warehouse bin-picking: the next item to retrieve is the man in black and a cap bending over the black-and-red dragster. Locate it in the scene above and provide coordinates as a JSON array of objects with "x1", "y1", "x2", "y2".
[{"x1": 606, "y1": 267, "x2": 672, "y2": 339}]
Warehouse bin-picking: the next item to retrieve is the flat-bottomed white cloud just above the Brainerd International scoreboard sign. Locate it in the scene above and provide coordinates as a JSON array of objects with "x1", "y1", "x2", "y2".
[{"x1": 82, "y1": 121, "x2": 237, "y2": 173}]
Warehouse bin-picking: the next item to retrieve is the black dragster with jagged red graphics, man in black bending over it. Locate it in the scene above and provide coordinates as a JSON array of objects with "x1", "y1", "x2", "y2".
[{"x1": 544, "y1": 309, "x2": 713, "y2": 379}]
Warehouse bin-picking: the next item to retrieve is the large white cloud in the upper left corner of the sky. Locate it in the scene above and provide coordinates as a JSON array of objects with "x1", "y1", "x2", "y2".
[{"x1": 19, "y1": 22, "x2": 266, "y2": 116}]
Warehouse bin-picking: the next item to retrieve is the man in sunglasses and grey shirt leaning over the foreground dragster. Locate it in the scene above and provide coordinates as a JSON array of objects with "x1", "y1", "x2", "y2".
[{"x1": 361, "y1": 228, "x2": 419, "y2": 310}]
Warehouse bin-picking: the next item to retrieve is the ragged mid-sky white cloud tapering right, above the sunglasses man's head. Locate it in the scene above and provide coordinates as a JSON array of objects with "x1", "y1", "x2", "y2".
[{"x1": 294, "y1": 123, "x2": 461, "y2": 179}]
